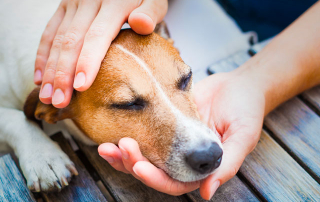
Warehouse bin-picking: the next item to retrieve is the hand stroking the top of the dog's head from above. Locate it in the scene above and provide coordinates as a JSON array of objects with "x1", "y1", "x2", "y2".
[{"x1": 34, "y1": 0, "x2": 168, "y2": 108}]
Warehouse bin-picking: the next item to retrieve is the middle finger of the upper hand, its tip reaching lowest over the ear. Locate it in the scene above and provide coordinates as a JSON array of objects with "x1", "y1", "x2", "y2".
[{"x1": 52, "y1": 1, "x2": 100, "y2": 108}]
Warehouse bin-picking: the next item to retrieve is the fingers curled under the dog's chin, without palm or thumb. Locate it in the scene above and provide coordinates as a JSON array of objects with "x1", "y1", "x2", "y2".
[{"x1": 98, "y1": 138, "x2": 200, "y2": 196}]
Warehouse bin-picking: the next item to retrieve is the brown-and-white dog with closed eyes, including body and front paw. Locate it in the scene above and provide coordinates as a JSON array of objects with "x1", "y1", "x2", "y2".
[{"x1": 0, "y1": 1, "x2": 223, "y2": 192}]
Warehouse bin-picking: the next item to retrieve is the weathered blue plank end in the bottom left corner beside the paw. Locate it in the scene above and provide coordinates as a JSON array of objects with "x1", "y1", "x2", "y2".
[{"x1": 0, "y1": 154, "x2": 35, "y2": 202}]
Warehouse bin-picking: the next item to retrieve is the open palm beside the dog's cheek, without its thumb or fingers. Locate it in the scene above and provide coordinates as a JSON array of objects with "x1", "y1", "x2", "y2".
[{"x1": 194, "y1": 73, "x2": 264, "y2": 141}]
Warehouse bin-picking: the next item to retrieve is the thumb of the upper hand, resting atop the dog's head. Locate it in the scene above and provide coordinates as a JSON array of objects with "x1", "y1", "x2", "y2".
[{"x1": 128, "y1": 0, "x2": 168, "y2": 35}]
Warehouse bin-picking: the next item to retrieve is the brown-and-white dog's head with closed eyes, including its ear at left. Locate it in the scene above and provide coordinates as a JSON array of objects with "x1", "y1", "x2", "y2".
[{"x1": 25, "y1": 23, "x2": 222, "y2": 182}]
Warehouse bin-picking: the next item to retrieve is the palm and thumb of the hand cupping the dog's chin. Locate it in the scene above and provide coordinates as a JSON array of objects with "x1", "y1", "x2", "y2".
[{"x1": 194, "y1": 73, "x2": 265, "y2": 196}]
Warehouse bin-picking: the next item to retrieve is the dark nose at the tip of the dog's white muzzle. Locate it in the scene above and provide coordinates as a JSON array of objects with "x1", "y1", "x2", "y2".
[{"x1": 186, "y1": 143, "x2": 223, "y2": 174}]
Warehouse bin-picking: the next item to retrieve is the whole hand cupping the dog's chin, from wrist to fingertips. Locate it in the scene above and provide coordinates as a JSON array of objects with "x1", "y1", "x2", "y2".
[{"x1": 98, "y1": 69, "x2": 265, "y2": 200}]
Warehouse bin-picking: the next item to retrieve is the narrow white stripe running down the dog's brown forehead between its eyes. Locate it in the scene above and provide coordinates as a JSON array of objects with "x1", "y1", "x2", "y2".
[{"x1": 116, "y1": 44, "x2": 178, "y2": 112}]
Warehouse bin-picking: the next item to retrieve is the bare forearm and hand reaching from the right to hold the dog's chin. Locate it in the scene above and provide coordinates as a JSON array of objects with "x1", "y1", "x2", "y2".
[{"x1": 98, "y1": 2, "x2": 320, "y2": 200}]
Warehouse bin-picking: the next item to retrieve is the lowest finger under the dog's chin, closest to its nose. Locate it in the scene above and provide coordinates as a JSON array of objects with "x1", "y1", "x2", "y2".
[{"x1": 133, "y1": 161, "x2": 200, "y2": 196}]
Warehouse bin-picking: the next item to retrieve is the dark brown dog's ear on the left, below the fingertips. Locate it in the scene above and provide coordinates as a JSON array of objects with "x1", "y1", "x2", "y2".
[{"x1": 23, "y1": 87, "x2": 71, "y2": 123}]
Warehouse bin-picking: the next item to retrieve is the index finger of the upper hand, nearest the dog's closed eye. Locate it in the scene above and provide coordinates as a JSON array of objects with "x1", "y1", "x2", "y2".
[{"x1": 73, "y1": 0, "x2": 138, "y2": 91}]
